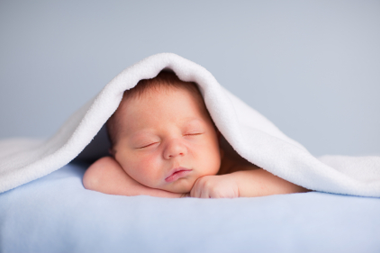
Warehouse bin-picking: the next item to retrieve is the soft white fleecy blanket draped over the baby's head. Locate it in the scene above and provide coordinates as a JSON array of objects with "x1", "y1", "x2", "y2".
[{"x1": 0, "y1": 53, "x2": 380, "y2": 197}]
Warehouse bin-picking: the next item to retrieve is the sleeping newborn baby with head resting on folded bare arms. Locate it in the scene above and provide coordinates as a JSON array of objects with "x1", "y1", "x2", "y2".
[{"x1": 83, "y1": 71, "x2": 306, "y2": 198}]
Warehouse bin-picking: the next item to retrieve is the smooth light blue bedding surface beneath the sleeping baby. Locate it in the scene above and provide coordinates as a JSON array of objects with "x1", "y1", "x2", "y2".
[{"x1": 0, "y1": 164, "x2": 380, "y2": 252}]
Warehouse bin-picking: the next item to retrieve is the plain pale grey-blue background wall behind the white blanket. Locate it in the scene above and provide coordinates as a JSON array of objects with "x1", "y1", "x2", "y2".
[{"x1": 0, "y1": 0, "x2": 380, "y2": 155}]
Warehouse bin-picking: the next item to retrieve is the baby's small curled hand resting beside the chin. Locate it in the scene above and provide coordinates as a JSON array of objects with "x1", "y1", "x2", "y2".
[{"x1": 190, "y1": 174, "x2": 239, "y2": 198}]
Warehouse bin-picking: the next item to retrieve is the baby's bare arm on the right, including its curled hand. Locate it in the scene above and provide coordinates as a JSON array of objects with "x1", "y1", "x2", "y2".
[{"x1": 190, "y1": 169, "x2": 308, "y2": 198}]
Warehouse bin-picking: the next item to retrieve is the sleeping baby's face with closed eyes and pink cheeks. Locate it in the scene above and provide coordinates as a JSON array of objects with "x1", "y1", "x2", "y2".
[{"x1": 114, "y1": 87, "x2": 221, "y2": 193}]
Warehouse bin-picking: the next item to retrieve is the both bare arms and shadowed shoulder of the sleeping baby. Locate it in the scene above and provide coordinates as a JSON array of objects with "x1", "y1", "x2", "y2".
[{"x1": 83, "y1": 150, "x2": 308, "y2": 198}]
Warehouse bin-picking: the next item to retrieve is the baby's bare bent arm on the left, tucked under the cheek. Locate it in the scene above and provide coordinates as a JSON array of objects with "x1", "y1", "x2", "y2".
[{"x1": 83, "y1": 157, "x2": 181, "y2": 198}]
